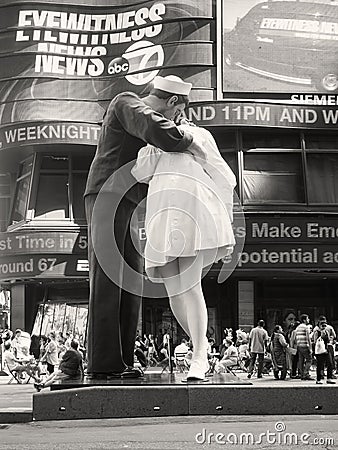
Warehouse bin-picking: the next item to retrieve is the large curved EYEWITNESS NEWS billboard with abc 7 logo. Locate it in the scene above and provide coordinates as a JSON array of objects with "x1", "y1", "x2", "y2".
[{"x1": 0, "y1": 0, "x2": 215, "y2": 126}]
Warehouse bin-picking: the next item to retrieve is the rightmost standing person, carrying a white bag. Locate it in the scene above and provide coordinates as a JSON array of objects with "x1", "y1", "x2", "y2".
[{"x1": 313, "y1": 320, "x2": 336, "y2": 384}]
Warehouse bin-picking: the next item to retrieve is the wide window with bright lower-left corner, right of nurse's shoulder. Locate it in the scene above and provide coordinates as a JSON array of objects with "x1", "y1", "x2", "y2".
[{"x1": 243, "y1": 152, "x2": 305, "y2": 203}]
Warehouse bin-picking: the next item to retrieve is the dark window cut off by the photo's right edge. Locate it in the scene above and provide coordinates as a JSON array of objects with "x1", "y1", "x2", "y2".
[{"x1": 306, "y1": 153, "x2": 338, "y2": 203}]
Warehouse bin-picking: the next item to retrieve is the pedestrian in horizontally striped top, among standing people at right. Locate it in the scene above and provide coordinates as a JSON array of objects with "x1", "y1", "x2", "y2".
[{"x1": 295, "y1": 314, "x2": 313, "y2": 380}]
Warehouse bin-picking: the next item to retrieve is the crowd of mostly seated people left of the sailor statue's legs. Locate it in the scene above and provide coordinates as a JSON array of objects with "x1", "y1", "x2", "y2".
[{"x1": 0, "y1": 329, "x2": 84, "y2": 391}]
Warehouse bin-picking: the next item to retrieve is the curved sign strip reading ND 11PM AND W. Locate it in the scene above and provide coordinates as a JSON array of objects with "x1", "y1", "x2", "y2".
[{"x1": 187, "y1": 102, "x2": 338, "y2": 129}]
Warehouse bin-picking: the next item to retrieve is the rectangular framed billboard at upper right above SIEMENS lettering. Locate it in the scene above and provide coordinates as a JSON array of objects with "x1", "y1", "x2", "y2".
[{"x1": 222, "y1": 0, "x2": 338, "y2": 97}]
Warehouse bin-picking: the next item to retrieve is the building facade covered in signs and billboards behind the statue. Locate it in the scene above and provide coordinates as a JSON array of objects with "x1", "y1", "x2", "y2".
[{"x1": 0, "y1": 0, "x2": 338, "y2": 342}]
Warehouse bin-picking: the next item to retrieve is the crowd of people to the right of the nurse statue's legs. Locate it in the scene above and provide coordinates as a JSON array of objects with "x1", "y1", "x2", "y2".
[{"x1": 202, "y1": 314, "x2": 338, "y2": 384}]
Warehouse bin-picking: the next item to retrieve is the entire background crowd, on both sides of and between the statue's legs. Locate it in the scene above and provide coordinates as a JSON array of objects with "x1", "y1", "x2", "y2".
[{"x1": 0, "y1": 314, "x2": 338, "y2": 391}]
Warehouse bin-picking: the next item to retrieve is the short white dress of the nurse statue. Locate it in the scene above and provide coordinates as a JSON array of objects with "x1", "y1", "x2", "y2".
[{"x1": 132, "y1": 125, "x2": 236, "y2": 282}]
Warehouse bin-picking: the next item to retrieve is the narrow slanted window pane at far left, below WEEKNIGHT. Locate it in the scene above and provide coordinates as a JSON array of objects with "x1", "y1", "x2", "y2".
[{"x1": 10, "y1": 157, "x2": 33, "y2": 225}]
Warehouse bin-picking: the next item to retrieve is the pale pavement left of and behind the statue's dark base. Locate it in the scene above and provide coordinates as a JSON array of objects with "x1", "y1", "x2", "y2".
[{"x1": 0, "y1": 367, "x2": 338, "y2": 423}]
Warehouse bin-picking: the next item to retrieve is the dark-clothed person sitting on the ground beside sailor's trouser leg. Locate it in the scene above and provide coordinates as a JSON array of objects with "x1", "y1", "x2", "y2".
[{"x1": 34, "y1": 339, "x2": 83, "y2": 392}]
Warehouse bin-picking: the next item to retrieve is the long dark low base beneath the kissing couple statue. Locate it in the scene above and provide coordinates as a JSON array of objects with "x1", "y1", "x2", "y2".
[{"x1": 33, "y1": 375, "x2": 338, "y2": 420}]
